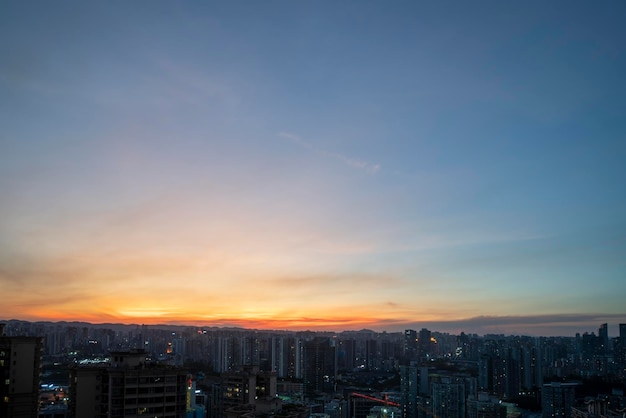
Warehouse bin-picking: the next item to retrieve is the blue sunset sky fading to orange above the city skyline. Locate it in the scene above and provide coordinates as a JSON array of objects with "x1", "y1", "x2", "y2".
[{"x1": 0, "y1": 0, "x2": 626, "y2": 336}]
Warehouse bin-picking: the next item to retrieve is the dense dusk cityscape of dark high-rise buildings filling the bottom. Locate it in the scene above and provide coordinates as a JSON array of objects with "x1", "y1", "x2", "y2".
[{"x1": 0, "y1": 321, "x2": 626, "y2": 418}]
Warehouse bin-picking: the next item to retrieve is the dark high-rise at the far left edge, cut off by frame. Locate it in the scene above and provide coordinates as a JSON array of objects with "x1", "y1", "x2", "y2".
[{"x1": 0, "y1": 324, "x2": 43, "y2": 418}]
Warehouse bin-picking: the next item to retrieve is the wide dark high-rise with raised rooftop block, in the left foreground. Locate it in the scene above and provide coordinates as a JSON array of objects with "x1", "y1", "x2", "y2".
[{"x1": 69, "y1": 350, "x2": 191, "y2": 418}]
